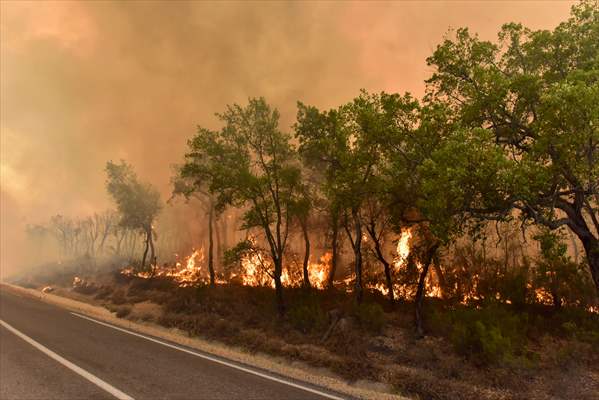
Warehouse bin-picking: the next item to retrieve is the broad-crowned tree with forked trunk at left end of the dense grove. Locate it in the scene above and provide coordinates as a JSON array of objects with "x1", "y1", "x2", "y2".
[{"x1": 185, "y1": 98, "x2": 301, "y2": 314}]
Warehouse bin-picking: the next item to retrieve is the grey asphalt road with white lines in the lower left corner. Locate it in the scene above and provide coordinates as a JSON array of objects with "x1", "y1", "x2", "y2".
[{"x1": 0, "y1": 289, "x2": 340, "y2": 400}]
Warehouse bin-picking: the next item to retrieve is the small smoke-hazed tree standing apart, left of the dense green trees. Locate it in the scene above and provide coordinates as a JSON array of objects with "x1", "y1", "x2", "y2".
[{"x1": 106, "y1": 161, "x2": 162, "y2": 269}]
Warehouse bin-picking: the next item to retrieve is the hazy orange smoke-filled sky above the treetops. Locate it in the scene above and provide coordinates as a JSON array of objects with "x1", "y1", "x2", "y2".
[{"x1": 0, "y1": 1, "x2": 573, "y2": 272}]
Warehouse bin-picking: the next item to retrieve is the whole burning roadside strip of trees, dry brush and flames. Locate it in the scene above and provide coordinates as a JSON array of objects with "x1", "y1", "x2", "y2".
[{"x1": 10, "y1": 0, "x2": 599, "y2": 399}]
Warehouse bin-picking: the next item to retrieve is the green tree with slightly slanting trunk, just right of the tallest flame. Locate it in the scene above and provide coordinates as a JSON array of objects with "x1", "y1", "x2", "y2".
[{"x1": 379, "y1": 94, "x2": 480, "y2": 335}]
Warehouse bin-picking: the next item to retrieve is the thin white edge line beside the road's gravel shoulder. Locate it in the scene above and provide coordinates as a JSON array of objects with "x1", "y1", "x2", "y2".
[{"x1": 71, "y1": 312, "x2": 344, "y2": 400}]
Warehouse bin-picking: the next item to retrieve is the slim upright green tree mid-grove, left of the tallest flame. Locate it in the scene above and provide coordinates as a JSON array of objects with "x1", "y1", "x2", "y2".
[{"x1": 295, "y1": 92, "x2": 394, "y2": 302}]
